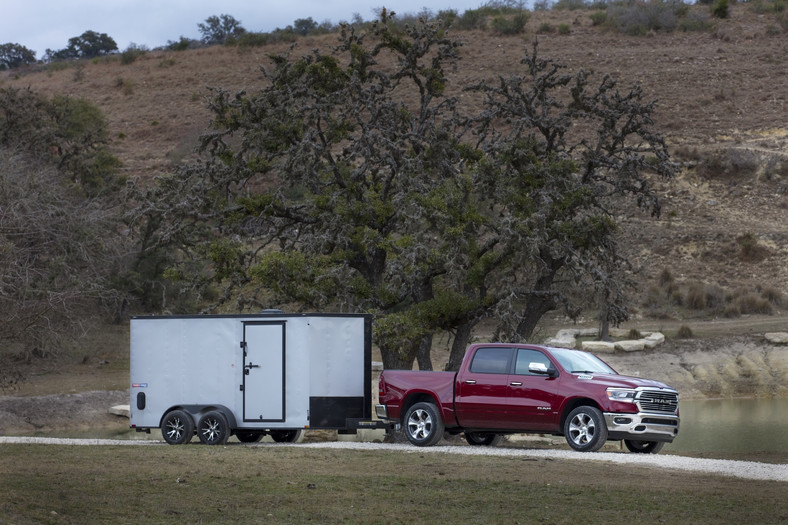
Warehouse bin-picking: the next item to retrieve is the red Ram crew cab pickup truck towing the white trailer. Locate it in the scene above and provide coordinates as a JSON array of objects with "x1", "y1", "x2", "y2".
[{"x1": 376, "y1": 343, "x2": 679, "y2": 454}]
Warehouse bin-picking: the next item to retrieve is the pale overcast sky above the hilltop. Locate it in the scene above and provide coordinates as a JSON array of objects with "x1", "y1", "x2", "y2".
[{"x1": 0, "y1": 0, "x2": 486, "y2": 59}]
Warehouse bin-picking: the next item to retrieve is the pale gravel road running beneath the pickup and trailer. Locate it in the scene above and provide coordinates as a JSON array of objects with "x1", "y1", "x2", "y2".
[{"x1": 0, "y1": 436, "x2": 788, "y2": 481}]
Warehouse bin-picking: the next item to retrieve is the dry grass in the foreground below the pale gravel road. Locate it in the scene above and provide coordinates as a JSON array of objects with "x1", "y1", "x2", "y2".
[{"x1": 0, "y1": 445, "x2": 788, "y2": 523}]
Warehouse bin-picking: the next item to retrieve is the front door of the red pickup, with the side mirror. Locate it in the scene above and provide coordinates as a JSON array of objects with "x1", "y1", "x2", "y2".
[{"x1": 507, "y1": 348, "x2": 561, "y2": 431}]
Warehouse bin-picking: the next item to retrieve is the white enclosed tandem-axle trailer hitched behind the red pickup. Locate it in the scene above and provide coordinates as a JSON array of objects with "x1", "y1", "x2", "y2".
[{"x1": 130, "y1": 313, "x2": 381, "y2": 444}]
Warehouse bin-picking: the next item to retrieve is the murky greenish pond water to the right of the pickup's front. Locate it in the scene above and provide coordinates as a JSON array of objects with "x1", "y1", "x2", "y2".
[{"x1": 664, "y1": 399, "x2": 788, "y2": 453}]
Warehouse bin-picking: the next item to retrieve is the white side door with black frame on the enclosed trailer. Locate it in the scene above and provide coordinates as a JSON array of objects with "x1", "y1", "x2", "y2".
[{"x1": 241, "y1": 321, "x2": 286, "y2": 422}]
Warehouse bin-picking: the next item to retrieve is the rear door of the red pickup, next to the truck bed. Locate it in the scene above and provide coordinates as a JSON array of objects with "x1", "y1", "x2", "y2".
[{"x1": 454, "y1": 346, "x2": 514, "y2": 429}]
